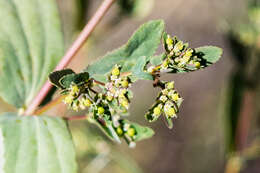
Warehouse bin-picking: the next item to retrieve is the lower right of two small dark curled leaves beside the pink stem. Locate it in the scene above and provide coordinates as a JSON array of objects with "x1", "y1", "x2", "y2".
[{"x1": 59, "y1": 72, "x2": 89, "y2": 88}]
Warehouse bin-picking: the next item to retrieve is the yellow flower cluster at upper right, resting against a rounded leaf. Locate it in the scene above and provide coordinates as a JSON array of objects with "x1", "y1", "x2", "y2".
[{"x1": 148, "y1": 35, "x2": 203, "y2": 73}]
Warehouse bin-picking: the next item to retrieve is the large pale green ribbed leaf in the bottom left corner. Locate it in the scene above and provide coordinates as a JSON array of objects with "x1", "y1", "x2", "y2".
[{"x1": 0, "y1": 113, "x2": 77, "y2": 173}]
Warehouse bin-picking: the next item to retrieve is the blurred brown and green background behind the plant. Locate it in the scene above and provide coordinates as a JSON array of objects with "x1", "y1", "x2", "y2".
[{"x1": 0, "y1": 0, "x2": 260, "y2": 173}]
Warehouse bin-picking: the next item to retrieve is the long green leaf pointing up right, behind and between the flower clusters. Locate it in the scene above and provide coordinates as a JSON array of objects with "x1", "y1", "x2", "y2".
[{"x1": 85, "y1": 20, "x2": 164, "y2": 81}]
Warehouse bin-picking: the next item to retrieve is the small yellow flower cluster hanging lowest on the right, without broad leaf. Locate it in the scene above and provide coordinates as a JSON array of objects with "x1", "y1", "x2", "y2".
[{"x1": 145, "y1": 81, "x2": 183, "y2": 126}]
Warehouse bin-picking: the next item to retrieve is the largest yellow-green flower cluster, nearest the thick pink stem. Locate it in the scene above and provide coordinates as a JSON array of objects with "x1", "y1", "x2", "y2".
[{"x1": 59, "y1": 65, "x2": 142, "y2": 147}]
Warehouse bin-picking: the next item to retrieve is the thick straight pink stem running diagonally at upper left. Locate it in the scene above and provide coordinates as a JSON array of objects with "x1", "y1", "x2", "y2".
[{"x1": 25, "y1": 0, "x2": 116, "y2": 115}]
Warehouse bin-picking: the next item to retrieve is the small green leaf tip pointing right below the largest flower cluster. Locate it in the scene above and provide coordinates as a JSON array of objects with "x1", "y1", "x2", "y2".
[{"x1": 131, "y1": 123, "x2": 154, "y2": 141}]
